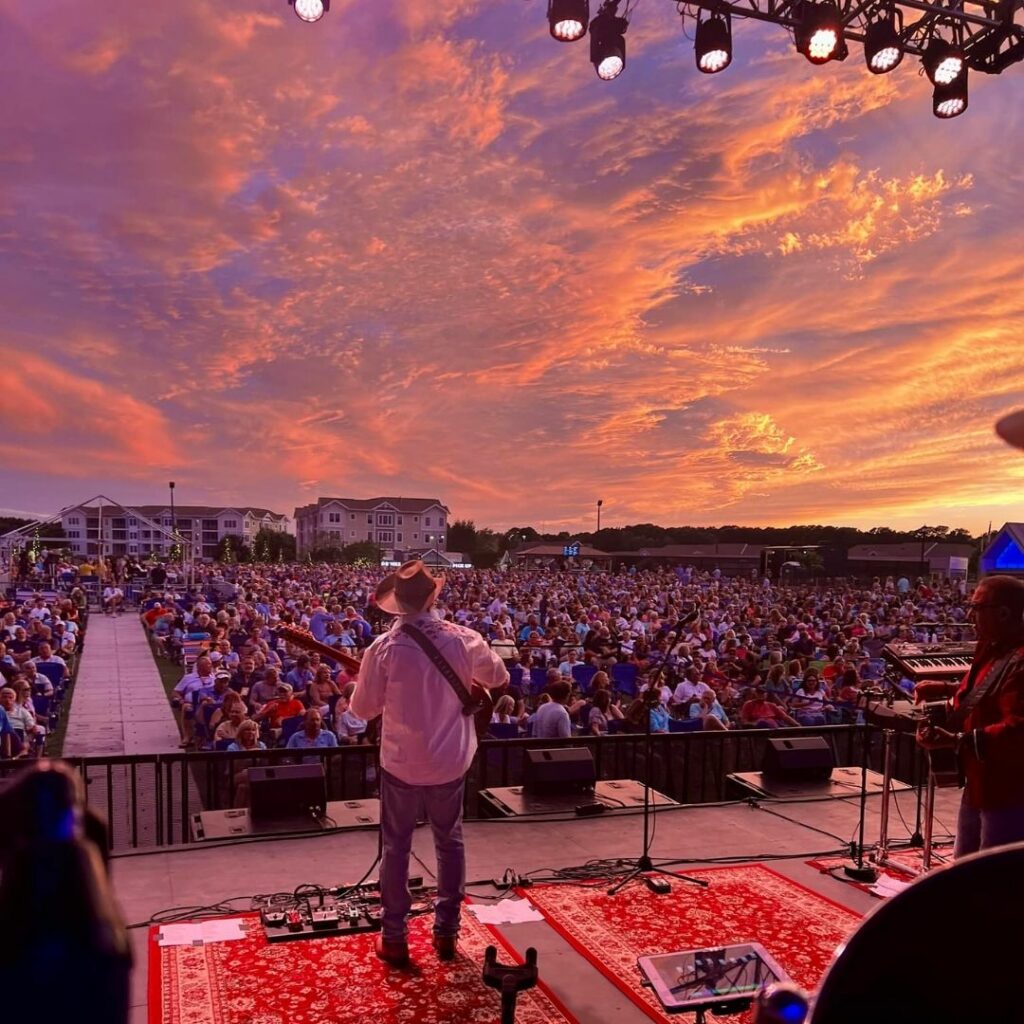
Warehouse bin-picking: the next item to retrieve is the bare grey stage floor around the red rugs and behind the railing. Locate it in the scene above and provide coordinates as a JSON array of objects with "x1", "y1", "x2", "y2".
[{"x1": 113, "y1": 790, "x2": 959, "y2": 1024}]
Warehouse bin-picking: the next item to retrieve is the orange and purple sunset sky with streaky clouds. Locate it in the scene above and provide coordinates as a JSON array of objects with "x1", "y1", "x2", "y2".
[{"x1": 0, "y1": 0, "x2": 1024, "y2": 532}]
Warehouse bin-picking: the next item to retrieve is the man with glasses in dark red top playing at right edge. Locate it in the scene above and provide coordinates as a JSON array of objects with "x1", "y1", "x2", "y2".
[{"x1": 914, "y1": 575, "x2": 1024, "y2": 857}]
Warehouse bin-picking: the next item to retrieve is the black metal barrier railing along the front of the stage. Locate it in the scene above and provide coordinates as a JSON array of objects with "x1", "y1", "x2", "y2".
[{"x1": 0, "y1": 725, "x2": 921, "y2": 850}]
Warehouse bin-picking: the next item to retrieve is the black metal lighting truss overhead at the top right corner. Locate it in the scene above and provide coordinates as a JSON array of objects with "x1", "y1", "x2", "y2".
[{"x1": 675, "y1": 0, "x2": 1024, "y2": 75}]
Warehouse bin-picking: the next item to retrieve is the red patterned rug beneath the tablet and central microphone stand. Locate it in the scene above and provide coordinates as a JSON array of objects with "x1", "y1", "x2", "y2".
[{"x1": 522, "y1": 864, "x2": 860, "y2": 1021}]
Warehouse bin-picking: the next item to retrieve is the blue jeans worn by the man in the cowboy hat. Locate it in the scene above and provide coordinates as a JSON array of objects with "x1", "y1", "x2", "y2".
[{"x1": 380, "y1": 771, "x2": 466, "y2": 942}]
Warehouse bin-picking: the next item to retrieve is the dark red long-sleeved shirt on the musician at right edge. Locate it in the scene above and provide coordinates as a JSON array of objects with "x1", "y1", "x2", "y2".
[{"x1": 953, "y1": 646, "x2": 1024, "y2": 811}]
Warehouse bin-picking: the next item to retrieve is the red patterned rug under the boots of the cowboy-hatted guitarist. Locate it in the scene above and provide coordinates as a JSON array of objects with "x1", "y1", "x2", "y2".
[{"x1": 148, "y1": 913, "x2": 575, "y2": 1024}]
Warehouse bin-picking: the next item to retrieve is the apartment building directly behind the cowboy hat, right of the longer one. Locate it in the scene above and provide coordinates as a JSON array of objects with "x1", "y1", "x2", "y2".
[{"x1": 295, "y1": 498, "x2": 451, "y2": 558}]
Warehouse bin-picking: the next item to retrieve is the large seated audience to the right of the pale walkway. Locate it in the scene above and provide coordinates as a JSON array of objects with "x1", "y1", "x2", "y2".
[{"x1": 132, "y1": 564, "x2": 971, "y2": 750}]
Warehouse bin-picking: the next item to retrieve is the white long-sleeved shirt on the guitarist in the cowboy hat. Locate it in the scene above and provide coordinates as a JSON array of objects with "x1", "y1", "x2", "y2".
[{"x1": 350, "y1": 612, "x2": 509, "y2": 785}]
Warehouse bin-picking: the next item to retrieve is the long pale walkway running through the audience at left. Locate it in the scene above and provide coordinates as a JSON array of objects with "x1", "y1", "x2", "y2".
[{"x1": 63, "y1": 611, "x2": 179, "y2": 757}]
